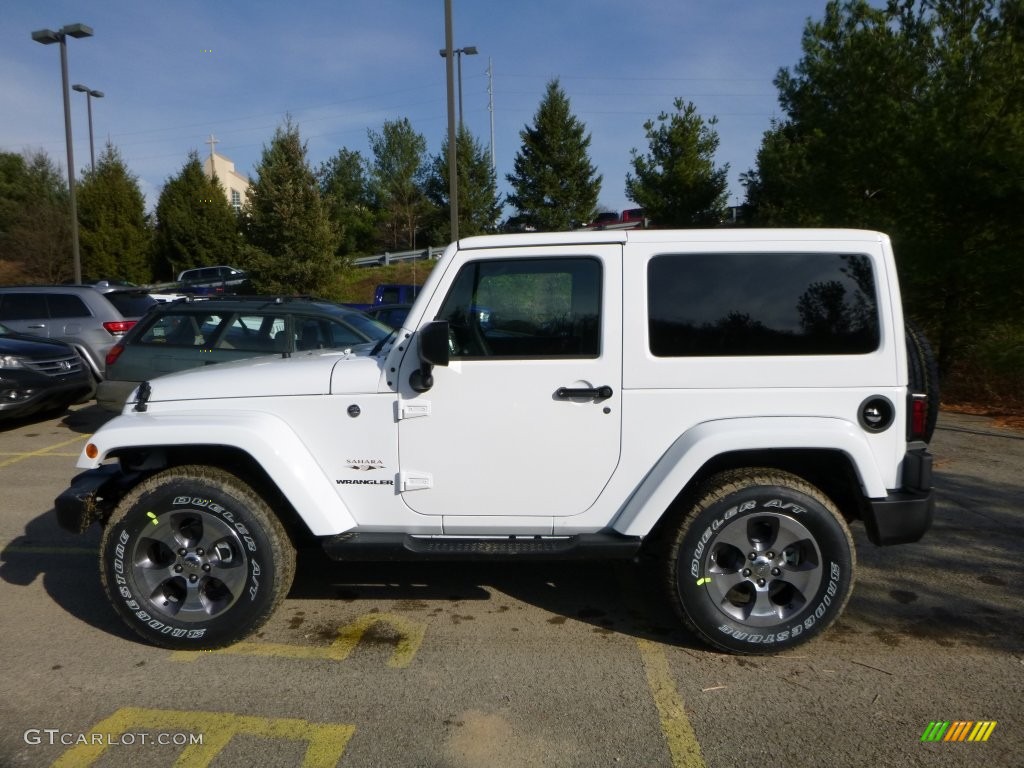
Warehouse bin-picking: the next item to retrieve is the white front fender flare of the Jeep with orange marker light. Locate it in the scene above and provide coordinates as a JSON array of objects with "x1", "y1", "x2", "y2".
[{"x1": 77, "y1": 411, "x2": 355, "y2": 536}]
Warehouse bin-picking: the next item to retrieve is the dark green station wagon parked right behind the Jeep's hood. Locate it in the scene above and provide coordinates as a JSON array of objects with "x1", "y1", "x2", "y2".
[{"x1": 96, "y1": 296, "x2": 391, "y2": 412}]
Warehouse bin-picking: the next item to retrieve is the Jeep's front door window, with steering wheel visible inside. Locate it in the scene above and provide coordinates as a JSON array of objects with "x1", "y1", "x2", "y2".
[{"x1": 437, "y1": 257, "x2": 601, "y2": 359}]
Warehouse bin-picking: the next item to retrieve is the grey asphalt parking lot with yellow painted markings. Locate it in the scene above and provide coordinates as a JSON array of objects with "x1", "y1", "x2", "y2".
[{"x1": 0, "y1": 406, "x2": 1024, "y2": 768}]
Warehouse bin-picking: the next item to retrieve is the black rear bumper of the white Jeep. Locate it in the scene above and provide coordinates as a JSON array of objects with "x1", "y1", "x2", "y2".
[{"x1": 864, "y1": 443, "x2": 935, "y2": 546}]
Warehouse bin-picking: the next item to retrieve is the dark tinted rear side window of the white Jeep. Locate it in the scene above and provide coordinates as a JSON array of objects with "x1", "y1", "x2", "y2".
[{"x1": 647, "y1": 253, "x2": 879, "y2": 357}]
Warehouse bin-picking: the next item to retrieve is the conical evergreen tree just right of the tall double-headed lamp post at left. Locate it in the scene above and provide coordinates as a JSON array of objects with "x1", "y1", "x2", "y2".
[{"x1": 76, "y1": 143, "x2": 153, "y2": 283}]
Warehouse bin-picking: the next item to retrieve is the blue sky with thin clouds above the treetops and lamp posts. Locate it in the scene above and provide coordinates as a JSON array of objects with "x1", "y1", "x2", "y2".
[{"x1": 0, "y1": 0, "x2": 826, "y2": 218}]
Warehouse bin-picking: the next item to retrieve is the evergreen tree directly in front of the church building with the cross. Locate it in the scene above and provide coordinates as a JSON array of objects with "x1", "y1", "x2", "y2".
[{"x1": 154, "y1": 150, "x2": 241, "y2": 280}]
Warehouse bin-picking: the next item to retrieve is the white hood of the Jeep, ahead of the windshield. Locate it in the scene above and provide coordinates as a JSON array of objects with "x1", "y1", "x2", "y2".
[{"x1": 138, "y1": 350, "x2": 381, "y2": 407}]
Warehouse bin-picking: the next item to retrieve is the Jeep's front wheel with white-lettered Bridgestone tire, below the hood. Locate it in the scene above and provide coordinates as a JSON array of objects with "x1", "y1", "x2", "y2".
[{"x1": 99, "y1": 466, "x2": 295, "y2": 650}]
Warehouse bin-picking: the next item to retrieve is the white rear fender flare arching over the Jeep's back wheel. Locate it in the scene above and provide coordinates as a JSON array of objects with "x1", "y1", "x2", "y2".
[{"x1": 612, "y1": 417, "x2": 888, "y2": 537}]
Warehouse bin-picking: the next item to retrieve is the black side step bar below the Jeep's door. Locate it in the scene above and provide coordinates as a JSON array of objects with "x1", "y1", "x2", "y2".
[{"x1": 323, "y1": 532, "x2": 641, "y2": 562}]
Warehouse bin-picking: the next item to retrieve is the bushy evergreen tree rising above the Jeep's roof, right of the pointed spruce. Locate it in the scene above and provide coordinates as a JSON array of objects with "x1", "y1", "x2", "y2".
[{"x1": 626, "y1": 98, "x2": 729, "y2": 227}]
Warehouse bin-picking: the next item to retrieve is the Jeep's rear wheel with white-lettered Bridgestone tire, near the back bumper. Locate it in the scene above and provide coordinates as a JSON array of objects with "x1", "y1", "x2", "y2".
[{"x1": 665, "y1": 469, "x2": 856, "y2": 654}]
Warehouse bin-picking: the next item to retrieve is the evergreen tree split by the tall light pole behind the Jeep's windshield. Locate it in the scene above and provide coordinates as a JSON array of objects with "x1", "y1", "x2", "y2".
[{"x1": 426, "y1": 127, "x2": 502, "y2": 244}]
